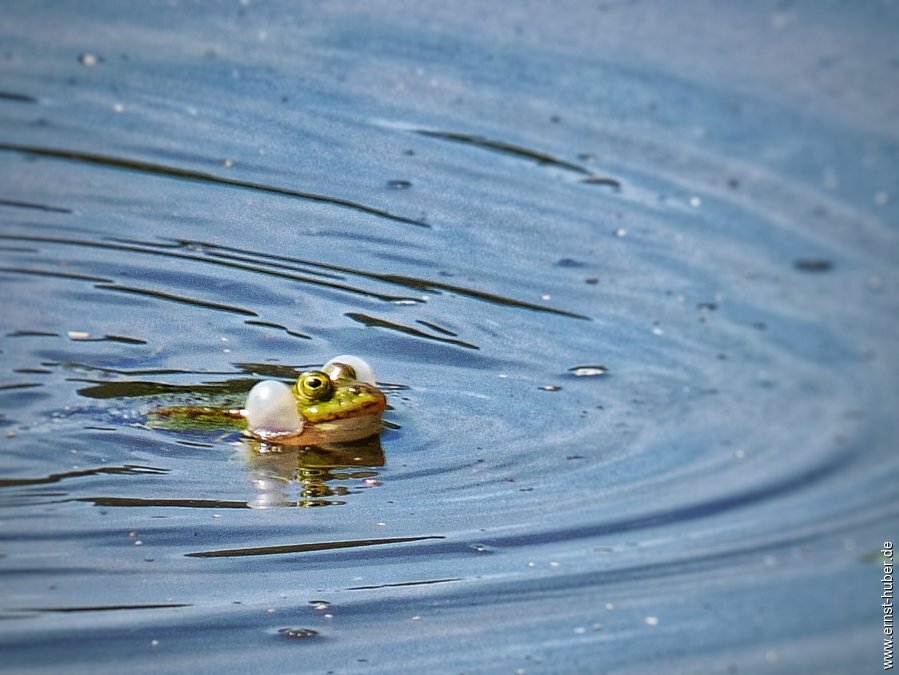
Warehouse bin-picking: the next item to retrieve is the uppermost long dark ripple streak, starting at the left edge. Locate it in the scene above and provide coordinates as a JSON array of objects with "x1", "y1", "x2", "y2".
[{"x1": 0, "y1": 143, "x2": 430, "y2": 227}]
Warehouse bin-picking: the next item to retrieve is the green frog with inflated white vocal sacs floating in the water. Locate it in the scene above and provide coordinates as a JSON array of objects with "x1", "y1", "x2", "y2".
[{"x1": 154, "y1": 354, "x2": 387, "y2": 446}]
